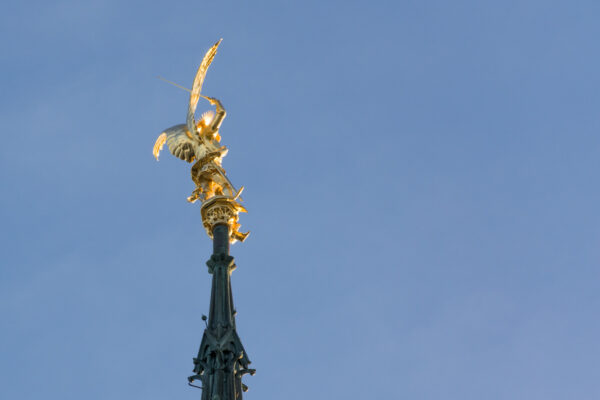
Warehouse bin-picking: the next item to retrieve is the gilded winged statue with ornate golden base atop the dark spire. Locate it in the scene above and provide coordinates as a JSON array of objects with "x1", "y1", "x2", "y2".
[{"x1": 152, "y1": 39, "x2": 249, "y2": 243}]
